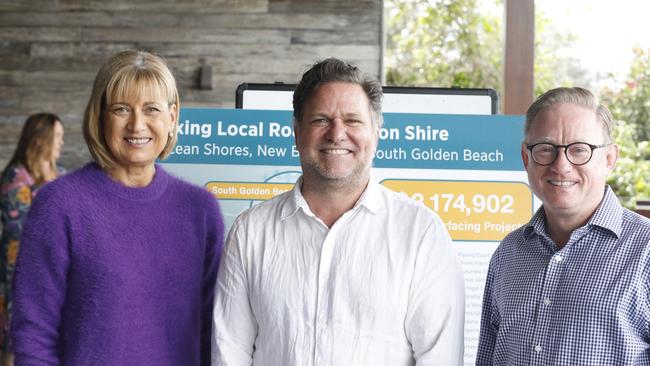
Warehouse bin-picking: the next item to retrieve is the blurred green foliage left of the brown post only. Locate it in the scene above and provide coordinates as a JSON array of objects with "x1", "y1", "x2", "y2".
[{"x1": 385, "y1": 0, "x2": 503, "y2": 91}]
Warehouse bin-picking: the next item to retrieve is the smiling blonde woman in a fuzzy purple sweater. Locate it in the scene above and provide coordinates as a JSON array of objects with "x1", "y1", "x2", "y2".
[{"x1": 12, "y1": 51, "x2": 223, "y2": 366}]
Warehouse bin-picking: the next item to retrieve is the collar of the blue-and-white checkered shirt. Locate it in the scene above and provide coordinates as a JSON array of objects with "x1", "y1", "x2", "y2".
[{"x1": 524, "y1": 185, "x2": 623, "y2": 239}]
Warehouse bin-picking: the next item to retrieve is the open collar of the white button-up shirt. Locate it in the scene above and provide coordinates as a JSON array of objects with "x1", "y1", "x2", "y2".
[{"x1": 281, "y1": 176, "x2": 384, "y2": 220}]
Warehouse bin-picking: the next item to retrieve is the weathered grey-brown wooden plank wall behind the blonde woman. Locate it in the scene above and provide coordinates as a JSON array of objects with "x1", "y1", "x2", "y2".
[{"x1": 0, "y1": 0, "x2": 383, "y2": 169}]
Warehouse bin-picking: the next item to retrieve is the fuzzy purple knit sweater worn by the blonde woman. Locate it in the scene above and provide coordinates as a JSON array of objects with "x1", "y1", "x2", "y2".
[{"x1": 11, "y1": 164, "x2": 223, "y2": 366}]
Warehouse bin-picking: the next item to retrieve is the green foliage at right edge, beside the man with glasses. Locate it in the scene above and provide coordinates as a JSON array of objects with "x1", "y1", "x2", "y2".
[{"x1": 600, "y1": 48, "x2": 650, "y2": 208}]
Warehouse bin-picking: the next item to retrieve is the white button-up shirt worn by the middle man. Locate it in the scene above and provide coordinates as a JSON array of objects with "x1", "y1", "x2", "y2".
[{"x1": 212, "y1": 180, "x2": 465, "y2": 366}]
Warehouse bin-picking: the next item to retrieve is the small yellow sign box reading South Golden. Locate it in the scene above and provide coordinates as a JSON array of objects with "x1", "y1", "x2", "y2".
[{"x1": 205, "y1": 182, "x2": 294, "y2": 201}]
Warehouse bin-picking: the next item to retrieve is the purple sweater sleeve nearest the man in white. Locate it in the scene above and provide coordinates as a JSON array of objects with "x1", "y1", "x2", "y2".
[{"x1": 201, "y1": 195, "x2": 224, "y2": 365}]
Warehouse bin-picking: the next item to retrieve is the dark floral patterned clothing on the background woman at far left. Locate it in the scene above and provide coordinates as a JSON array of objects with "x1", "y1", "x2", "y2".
[{"x1": 0, "y1": 165, "x2": 65, "y2": 352}]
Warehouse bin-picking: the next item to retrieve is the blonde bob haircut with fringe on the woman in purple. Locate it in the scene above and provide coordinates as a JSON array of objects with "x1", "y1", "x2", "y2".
[{"x1": 83, "y1": 50, "x2": 180, "y2": 169}]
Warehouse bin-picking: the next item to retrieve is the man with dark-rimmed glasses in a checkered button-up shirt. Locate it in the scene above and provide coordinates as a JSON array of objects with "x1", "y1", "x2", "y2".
[{"x1": 476, "y1": 88, "x2": 650, "y2": 366}]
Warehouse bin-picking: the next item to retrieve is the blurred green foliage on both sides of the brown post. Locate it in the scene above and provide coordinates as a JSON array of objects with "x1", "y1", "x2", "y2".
[{"x1": 384, "y1": 0, "x2": 590, "y2": 103}]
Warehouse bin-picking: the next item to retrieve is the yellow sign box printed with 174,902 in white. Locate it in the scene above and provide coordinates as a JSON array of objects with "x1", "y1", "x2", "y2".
[{"x1": 382, "y1": 179, "x2": 533, "y2": 241}]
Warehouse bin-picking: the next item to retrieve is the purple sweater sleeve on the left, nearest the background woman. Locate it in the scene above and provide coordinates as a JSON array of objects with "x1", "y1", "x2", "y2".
[{"x1": 11, "y1": 185, "x2": 70, "y2": 365}]
